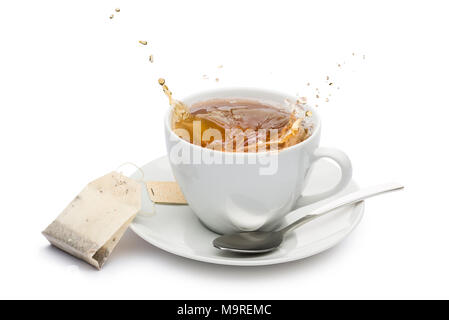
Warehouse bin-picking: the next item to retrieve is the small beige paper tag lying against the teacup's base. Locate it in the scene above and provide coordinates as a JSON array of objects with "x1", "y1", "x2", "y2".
[{"x1": 146, "y1": 181, "x2": 187, "y2": 204}]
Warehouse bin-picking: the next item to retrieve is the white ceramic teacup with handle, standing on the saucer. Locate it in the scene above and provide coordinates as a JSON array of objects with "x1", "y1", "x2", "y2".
[{"x1": 165, "y1": 88, "x2": 352, "y2": 234}]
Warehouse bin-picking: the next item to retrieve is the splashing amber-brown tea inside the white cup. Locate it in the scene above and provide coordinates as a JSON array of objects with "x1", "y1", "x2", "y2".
[{"x1": 159, "y1": 79, "x2": 312, "y2": 152}]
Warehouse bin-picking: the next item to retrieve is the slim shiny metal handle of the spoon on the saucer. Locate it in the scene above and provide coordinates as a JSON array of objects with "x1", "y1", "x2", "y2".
[{"x1": 279, "y1": 182, "x2": 404, "y2": 233}]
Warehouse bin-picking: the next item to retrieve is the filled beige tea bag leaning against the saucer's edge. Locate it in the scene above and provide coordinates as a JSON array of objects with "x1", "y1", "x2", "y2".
[{"x1": 42, "y1": 172, "x2": 141, "y2": 269}]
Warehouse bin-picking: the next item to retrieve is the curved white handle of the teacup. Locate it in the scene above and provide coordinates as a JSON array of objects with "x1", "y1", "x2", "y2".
[{"x1": 298, "y1": 148, "x2": 352, "y2": 206}]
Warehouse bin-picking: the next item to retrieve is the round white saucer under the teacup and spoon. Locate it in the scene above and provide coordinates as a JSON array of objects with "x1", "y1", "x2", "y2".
[{"x1": 131, "y1": 157, "x2": 364, "y2": 266}]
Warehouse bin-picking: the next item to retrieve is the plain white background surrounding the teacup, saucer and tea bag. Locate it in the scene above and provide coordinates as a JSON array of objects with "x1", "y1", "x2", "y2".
[{"x1": 0, "y1": 0, "x2": 449, "y2": 299}]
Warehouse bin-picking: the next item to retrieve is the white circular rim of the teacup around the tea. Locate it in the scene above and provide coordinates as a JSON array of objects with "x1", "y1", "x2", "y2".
[{"x1": 164, "y1": 87, "x2": 321, "y2": 156}]
